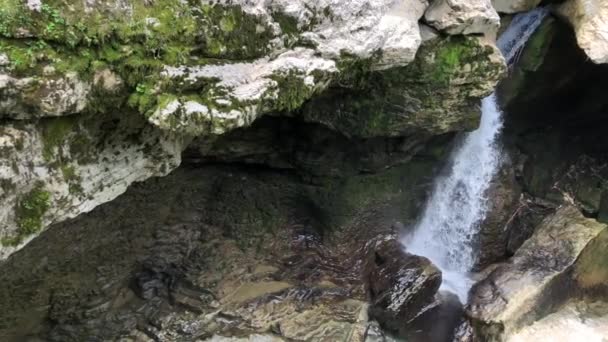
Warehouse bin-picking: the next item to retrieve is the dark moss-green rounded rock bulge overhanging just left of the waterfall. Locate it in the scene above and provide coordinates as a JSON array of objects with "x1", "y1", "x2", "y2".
[{"x1": 303, "y1": 36, "x2": 505, "y2": 137}]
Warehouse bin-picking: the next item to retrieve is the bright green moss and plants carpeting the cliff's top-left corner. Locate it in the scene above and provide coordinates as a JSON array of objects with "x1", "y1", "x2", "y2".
[{"x1": 0, "y1": 0, "x2": 275, "y2": 121}]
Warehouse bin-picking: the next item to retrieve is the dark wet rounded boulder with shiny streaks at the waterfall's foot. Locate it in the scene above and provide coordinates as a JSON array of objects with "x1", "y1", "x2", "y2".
[{"x1": 364, "y1": 235, "x2": 441, "y2": 331}]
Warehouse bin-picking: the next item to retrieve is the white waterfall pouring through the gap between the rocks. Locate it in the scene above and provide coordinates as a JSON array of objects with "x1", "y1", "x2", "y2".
[{"x1": 402, "y1": 8, "x2": 548, "y2": 303}]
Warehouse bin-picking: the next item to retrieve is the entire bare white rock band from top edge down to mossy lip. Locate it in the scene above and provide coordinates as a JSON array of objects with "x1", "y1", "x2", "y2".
[{"x1": 148, "y1": 0, "x2": 428, "y2": 135}]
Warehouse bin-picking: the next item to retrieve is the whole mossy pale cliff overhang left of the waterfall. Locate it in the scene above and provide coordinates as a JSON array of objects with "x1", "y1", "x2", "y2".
[{"x1": 0, "y1": 0, "x2": 504, "y2": 259}]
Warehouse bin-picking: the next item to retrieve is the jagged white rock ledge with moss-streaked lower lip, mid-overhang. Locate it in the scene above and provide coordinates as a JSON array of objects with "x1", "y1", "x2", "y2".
[{"x1": 156, "y1": 48, "x2": 338, "y2": 135}]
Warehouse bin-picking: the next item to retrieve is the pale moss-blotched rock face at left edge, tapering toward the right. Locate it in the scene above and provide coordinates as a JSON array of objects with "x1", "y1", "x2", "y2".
[{"x1": 0, "y1": 119, "x2": 184, "y2": 260}]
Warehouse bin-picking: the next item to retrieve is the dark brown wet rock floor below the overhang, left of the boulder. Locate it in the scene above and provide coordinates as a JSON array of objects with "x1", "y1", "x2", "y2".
[{"x1": 0, "y1": 149, "x2": 446, "y2": 341}]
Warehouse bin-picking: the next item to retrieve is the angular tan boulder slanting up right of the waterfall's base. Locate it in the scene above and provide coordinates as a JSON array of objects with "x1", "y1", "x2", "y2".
[{"x1": 467, "y1": 206, "x2": 606, "y2": 339}]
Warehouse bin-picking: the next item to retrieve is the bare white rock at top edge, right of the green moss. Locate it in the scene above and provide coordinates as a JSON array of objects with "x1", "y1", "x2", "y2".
[{"x1": 211, "y1": 0, "x2": 428, "y2": 68}]
